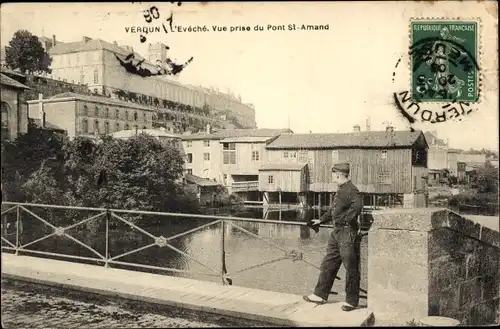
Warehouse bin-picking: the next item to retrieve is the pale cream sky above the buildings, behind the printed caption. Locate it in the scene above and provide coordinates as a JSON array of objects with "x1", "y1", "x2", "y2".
[{"x1": 0, "y1": 1, "x2": 499, "y2": 150}]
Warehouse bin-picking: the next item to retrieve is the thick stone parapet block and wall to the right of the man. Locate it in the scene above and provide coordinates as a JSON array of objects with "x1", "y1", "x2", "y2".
[{"x1": 368, "y1": 209, "x2": 500, "y2": 325}]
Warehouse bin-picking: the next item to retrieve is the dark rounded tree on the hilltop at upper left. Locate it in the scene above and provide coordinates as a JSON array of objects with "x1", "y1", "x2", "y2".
[{"x1": 5, "y1": 30, "x2": 52, "y2": 73}]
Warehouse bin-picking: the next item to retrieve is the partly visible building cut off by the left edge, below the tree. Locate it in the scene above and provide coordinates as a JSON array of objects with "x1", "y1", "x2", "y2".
[{"x1": 0, "y1": 73, "x2": 29, "y2": 140}]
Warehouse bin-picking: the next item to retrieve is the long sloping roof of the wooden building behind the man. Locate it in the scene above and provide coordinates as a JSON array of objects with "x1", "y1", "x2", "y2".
[{"x1": 266, "y1": 131, "x2": 423, "y2": 149}]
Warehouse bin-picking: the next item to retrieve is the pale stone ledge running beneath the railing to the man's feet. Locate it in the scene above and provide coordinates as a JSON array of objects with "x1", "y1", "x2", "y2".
[{"x1": 2, "y1": 253, "x2": 374, "y2": 327}]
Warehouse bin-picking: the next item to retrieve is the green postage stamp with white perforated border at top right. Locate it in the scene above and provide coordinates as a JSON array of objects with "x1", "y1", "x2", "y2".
[{"x1": 410, "y1": 19, "x2": 480, "y2": 102}]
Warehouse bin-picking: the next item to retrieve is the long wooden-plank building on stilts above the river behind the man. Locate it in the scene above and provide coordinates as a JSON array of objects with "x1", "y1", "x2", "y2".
[{"x1": 259, "y1": 129, "x2": 428, "y2": 206}]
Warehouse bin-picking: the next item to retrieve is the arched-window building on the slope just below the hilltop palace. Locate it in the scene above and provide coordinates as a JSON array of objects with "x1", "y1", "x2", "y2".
[{"x1": 28, "y1": 93, "x2": 154, "y2": 138}]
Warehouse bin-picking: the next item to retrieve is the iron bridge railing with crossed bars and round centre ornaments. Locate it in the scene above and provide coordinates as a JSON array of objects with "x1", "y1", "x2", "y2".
[{"x1": 1, "y1": 202, "x2": 366, "y2": 293}]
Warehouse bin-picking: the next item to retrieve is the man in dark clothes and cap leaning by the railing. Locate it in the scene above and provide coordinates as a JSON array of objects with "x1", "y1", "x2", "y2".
[{"x1": 304, "y1": 163, "x2": 362, "y2": 311}]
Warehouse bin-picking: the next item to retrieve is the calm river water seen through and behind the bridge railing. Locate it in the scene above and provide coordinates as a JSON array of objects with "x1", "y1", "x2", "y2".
[{"x1": 2, "y1": 207, "x2": 366, "y2": 294}]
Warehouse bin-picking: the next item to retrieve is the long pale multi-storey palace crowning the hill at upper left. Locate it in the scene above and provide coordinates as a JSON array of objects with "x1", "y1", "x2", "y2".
[{"x1": 40, "y1": 36, "x2": 256, "y2": 128}]
